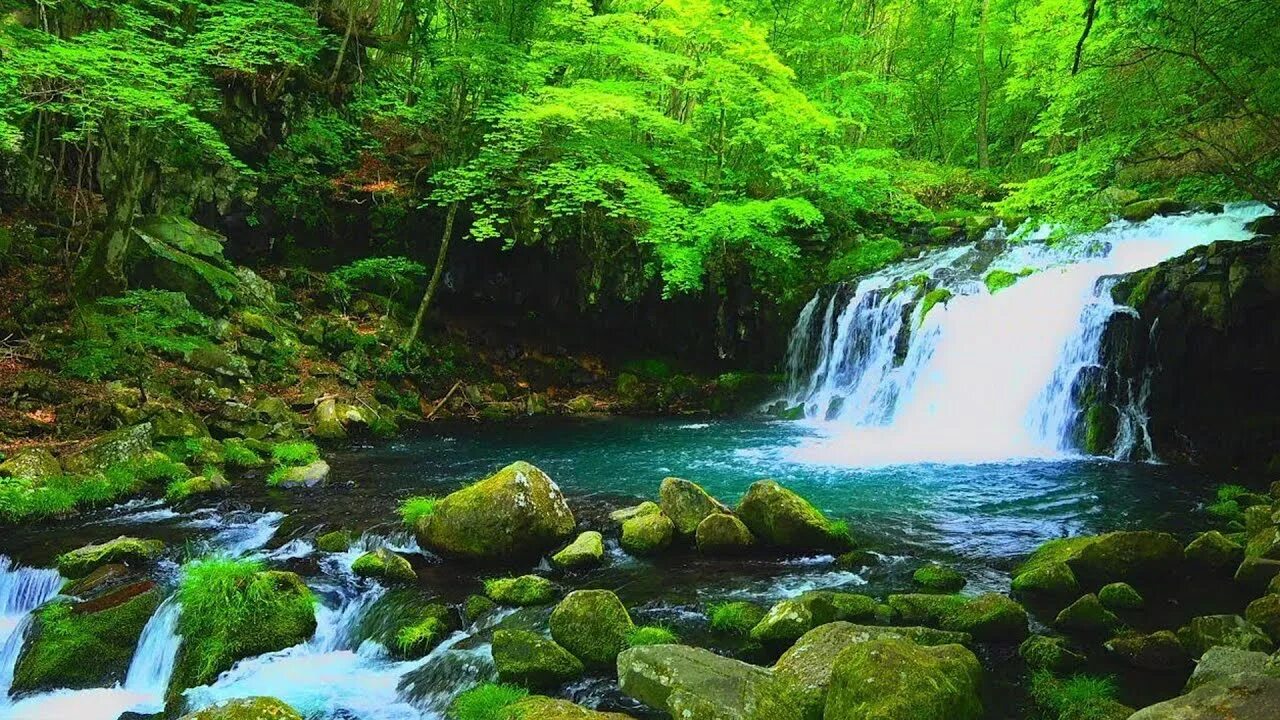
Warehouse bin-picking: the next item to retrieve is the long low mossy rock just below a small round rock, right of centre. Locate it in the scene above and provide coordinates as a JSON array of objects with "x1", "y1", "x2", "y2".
[{"x1": 888, "y1": 593, "x2": 1027, "y2": 641}]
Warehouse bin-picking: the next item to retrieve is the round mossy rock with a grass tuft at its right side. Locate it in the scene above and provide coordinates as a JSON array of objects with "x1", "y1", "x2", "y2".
[{"x1": 549, "y1": 589, "x2": 635, "y2": 667}]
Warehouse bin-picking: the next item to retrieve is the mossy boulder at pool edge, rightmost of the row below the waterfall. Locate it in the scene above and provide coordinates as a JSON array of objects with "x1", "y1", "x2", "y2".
[{"x1": 737, "y1": 480, "x2": 849, "y2": 550}]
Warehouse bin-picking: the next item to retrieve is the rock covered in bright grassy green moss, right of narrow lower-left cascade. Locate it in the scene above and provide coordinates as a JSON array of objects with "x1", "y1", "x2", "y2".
[{"x1": 174, "y1": 557, "x2": 316, "y2": 689}]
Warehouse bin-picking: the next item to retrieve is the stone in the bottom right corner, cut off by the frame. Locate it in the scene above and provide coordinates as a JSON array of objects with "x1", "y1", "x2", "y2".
[{"x1": 1129, "y1": 674, "x2": 1280, "y2": 720}]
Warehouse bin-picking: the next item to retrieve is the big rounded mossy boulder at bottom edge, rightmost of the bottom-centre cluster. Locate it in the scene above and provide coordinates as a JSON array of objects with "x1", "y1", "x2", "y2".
[{"x1": 823, "y1": 638, "x2": 983, "y2": 720}]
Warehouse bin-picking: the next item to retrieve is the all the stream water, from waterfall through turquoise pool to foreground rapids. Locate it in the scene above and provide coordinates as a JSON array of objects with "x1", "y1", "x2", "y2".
[{"x1": 0, "y1": 206, "x2": 1261, "y2": 720}]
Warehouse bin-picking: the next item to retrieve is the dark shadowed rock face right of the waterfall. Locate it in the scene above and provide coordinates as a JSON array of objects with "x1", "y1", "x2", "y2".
[{"x1": 1085, "y1": 237, "x2": 1280, "y2": 466}]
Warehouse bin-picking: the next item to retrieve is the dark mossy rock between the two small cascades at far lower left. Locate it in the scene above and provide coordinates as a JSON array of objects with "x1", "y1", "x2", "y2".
[{"x1": 13, "y1": 582, "x2": 160, "y2": 693}]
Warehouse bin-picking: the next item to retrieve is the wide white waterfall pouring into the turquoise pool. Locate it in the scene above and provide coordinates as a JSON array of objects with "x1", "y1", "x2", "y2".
[{"x1": 787, "y1": 204, "x2": 1267, "y2": 465}]
